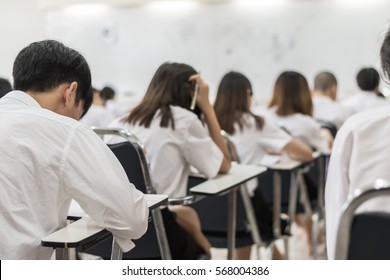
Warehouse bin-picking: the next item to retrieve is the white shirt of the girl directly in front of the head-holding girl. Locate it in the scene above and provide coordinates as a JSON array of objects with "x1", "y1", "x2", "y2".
[{"x1": 230, "y1": 114, "x2": 292, "y2": 195}]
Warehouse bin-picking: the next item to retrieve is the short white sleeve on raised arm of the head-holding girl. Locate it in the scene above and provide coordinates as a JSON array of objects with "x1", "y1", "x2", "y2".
[{"x1": 183, "y1": 119, "x2": 223, "y2": 178}]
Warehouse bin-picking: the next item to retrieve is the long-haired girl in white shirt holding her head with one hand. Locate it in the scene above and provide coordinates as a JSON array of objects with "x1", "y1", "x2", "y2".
[{"x1": 107, "y1": 63, "x2": 230, "y2": 259}]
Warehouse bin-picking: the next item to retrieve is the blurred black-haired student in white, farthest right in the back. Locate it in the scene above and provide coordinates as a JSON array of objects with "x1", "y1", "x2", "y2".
[{"x1": 343, "y1": 67, "x2": 389, "y2": 112}]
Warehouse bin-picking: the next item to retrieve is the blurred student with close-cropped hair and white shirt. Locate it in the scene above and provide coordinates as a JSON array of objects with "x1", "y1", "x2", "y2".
[{"x1": 312, "y1": 71, "x2": 355, "y2": 129}]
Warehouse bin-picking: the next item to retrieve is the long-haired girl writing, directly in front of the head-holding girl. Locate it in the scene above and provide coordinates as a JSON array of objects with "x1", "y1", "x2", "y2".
[{"x1": 214, "y1": 72, "x2": 312, "y2": 259}]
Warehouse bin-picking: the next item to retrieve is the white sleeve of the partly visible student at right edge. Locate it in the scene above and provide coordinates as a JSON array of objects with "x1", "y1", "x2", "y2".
[{"x1": 325, "y1": 126, "x2": 353, "y2": 259}]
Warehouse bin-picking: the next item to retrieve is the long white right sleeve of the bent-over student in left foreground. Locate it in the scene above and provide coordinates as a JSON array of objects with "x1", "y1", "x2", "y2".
[{"x1": 61, "y1": 125, "x2": 149, "y2": 252}]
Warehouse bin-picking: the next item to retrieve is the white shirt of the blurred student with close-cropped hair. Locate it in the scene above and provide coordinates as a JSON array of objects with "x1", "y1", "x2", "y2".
[{"x1": 312, "y1": 95, "x2": 355, "y2": 128}]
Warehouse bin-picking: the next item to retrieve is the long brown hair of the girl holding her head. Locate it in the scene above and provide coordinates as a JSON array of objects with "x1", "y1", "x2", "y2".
[{"x1": 126, "y1": 63, "x2": 200, "y2": 129}]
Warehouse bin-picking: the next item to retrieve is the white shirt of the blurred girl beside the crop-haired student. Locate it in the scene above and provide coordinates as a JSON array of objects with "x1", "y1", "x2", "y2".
[{"x1": 266, "y1": 108, "x2": 329, "y2": 154}]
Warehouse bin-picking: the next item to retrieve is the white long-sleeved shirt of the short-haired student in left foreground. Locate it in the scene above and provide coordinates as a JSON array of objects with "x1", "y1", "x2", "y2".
[{"x1": 0, "y1": 91, "x2": 149, "y2": 259}]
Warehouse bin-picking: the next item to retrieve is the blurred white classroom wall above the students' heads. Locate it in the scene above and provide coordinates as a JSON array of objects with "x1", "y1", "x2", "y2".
[{"x1": 0, "y1": 0, "x2": 390, "y2": 103}]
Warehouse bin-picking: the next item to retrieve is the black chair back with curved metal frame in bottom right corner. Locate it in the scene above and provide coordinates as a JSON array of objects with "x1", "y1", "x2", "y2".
[{"x1": 335, "y1": 180, "x2": 390, "y2": 260}]
